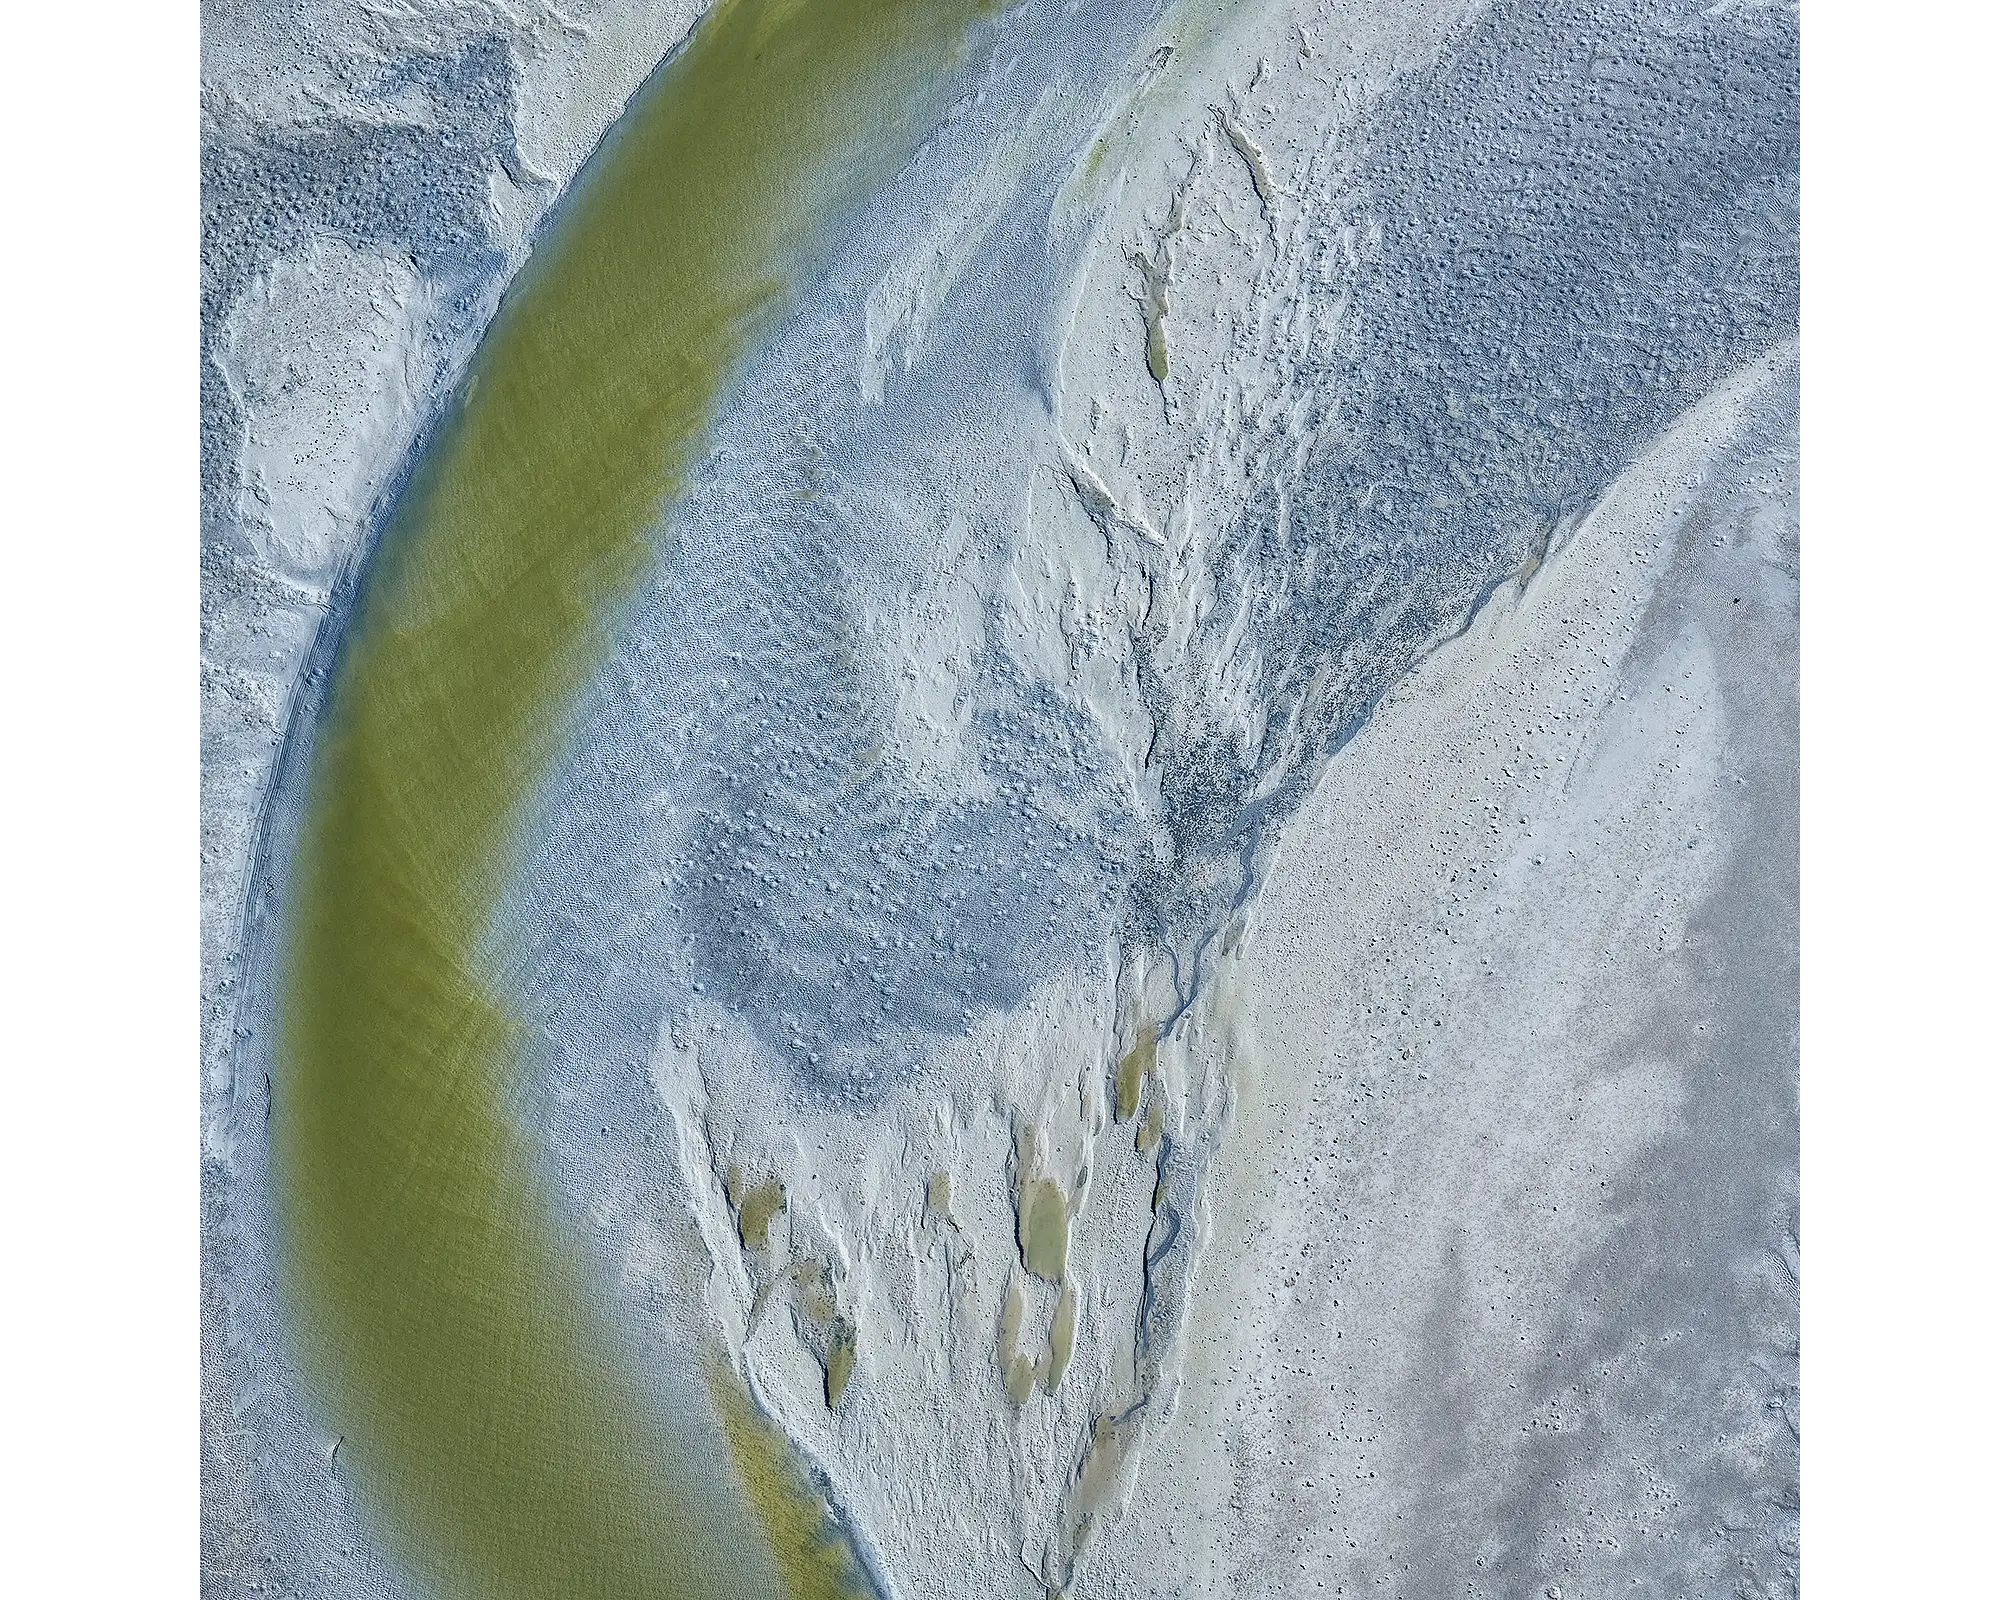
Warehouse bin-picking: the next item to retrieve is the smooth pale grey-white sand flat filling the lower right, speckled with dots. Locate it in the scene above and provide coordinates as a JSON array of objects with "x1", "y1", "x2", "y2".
[{"x1": 1092, "y1": 352, "x2": 1798, "y2": 1596}]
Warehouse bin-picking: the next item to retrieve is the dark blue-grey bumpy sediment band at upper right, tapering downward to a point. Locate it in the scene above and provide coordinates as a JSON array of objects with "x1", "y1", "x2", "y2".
[{"x1": 1130, "y1": 0, "x2": 1798, "y2": 996}]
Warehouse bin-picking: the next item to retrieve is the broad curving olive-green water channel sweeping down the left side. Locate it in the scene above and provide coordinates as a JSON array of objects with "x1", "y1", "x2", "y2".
[{"x1": 272, "y1": 0, "x2": 986, "y2": 1600}]
